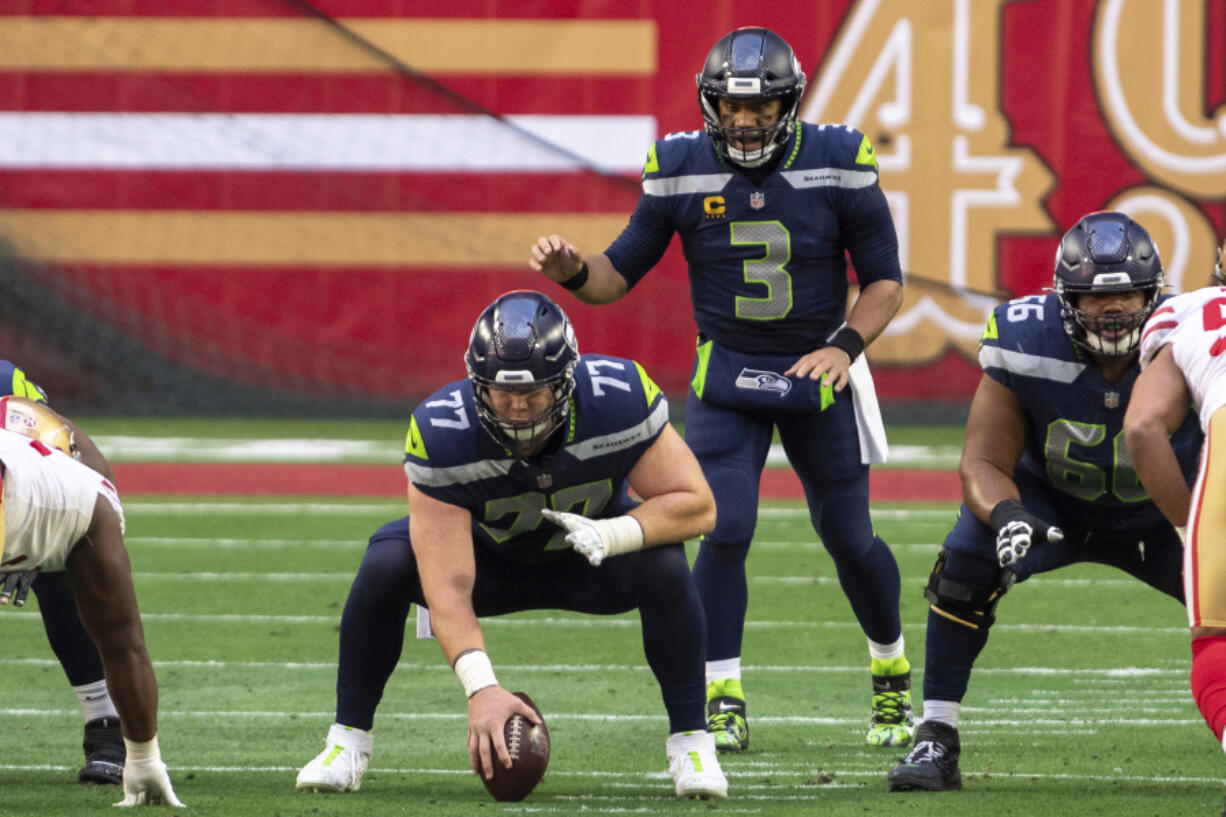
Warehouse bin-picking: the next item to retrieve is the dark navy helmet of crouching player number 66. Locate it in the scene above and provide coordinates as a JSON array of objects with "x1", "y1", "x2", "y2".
[{"x1": 1054, "y1": 211, "x2": 1166, "y2": 357}]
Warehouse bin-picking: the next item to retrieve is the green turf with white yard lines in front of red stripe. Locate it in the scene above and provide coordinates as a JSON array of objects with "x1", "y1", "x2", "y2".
[{"x1": 0, "y1": 426, "x2": 1224, "y2": 817}]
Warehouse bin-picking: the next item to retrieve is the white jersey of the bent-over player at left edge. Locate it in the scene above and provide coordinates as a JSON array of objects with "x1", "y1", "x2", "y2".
[{"x1": 0, "y1": 428, "x2": 124, "y2": 572}]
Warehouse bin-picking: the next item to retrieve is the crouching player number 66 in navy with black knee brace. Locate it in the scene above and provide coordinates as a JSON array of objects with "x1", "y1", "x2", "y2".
[{"x1": 888, "y1": 212, "x2": 1203, "y2": 791}]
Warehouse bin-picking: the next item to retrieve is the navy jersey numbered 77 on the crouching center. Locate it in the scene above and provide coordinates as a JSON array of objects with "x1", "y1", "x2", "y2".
[{"x1": 405, "y1": 355, "x2": 668, "y2": 563}]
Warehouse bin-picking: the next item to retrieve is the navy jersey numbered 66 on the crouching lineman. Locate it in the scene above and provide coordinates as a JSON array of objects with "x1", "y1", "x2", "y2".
[{"x1": 980, "y1": 293, "x2": 1203, "y2": 530}]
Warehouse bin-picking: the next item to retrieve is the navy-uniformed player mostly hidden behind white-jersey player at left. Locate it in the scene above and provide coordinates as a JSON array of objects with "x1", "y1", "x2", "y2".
[{"x1": 0, "y1": 361, "x2": 124, "y2": 785}]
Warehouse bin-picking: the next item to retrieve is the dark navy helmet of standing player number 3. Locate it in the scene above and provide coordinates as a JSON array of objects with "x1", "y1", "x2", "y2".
[{"x1": 695, "y1": 28, "x2": 804, "y2": 167}]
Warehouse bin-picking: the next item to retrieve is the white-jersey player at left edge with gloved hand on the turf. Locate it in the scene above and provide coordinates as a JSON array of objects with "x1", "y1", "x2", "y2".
[{"x1": 0, "y1": 397, "x2": 183, "y2": 806}]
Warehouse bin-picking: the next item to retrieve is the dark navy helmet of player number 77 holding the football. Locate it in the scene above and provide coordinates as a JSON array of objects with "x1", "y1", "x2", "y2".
[{"x1": 465, "y1": 290, "x2": 579, "y2": 450}]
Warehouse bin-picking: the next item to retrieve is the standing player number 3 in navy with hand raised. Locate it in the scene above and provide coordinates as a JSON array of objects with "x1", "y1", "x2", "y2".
[{"x1": 530, "y1": 28, "x2": 913, "y2": 752}]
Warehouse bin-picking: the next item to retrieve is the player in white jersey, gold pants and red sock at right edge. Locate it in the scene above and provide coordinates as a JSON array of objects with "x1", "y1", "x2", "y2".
[{"x1": 1124, "y1": 250, "x2": 1226, "y2": 790}]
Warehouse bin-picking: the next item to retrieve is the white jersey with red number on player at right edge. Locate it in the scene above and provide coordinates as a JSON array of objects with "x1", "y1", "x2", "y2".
[{"x1": 1141, "y1": 287, "x2": 1226, "y2": 432}]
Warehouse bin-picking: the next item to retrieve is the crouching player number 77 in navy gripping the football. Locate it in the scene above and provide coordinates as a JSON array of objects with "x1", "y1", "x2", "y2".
[{"x1": 297, "y1": 291, "x2": 728, "y2": 797}]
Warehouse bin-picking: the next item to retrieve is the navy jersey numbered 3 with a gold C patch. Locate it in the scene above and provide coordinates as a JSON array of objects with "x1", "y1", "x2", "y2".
[{"x1": 606, "y1": 124, "x2": 902, "y2": 355}]
